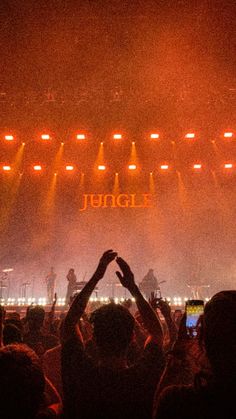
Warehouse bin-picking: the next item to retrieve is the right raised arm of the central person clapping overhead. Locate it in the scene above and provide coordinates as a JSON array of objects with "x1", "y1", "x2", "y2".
[{"x1": 116, "y1": 257, "x2": 163, "y2": 346}]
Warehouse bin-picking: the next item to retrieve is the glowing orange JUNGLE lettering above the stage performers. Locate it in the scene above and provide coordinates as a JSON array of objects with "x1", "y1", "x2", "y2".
[{"x1": 80, "y1": 193, "x2": 153, "y2": 211}]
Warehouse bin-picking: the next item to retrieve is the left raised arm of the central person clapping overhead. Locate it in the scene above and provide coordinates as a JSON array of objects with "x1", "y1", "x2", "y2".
[{"x1": 62, "y1": 250, "x2": 117, "y2": 342}]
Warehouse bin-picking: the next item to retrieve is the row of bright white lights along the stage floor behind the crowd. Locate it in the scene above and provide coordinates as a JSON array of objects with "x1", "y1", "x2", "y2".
[{"x1": 0, "y1": 297, "x2": 210, "y2": 307}]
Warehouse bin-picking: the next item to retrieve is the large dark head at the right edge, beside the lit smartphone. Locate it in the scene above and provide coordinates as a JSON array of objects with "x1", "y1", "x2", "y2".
[{"x1": 203, "y1": 291, "x2": 236, "y2": 378}]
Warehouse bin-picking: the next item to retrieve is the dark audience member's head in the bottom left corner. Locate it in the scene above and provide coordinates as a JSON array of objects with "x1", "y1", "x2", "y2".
[{"x1": 0, "y1": 345, "x2": 45, "y2": 419}]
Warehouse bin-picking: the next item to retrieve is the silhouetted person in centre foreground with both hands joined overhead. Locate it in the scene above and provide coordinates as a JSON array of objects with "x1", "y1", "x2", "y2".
[{"x1": 62, "y1": 250, "x2": 164, "y2": 419}]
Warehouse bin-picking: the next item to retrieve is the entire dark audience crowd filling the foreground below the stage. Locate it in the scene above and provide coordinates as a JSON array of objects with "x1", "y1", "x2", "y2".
[{"x1": 0, "y1": 250, "x2": 236, "y2": 419}]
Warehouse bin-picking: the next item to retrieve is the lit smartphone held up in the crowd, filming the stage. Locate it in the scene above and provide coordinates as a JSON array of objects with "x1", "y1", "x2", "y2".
[{"x1": 185, "y1": 300, "x2": 204, "y2": 338}]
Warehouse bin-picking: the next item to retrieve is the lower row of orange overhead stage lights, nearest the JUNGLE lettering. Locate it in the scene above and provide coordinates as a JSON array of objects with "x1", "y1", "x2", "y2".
[{"x1": 0, "y1": 162, "x2": 235, "y2": 175}]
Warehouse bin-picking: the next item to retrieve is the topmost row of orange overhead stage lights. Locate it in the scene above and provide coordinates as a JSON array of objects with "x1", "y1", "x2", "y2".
[{"x1": 0, "y1": 132, "x2": 234, "y2": 141}]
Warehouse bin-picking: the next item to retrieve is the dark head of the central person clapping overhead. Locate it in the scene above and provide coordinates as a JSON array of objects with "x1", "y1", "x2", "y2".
[{"x1": 90, "y1": 303, "x2": 134, "y2": 357}]
